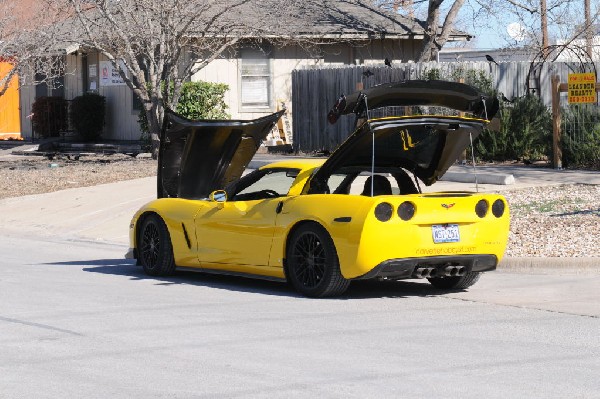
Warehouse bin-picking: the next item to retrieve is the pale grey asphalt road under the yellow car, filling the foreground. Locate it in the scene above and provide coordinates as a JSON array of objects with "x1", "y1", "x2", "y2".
[{"x1": 0, "y1": 235, "x2": 600, "y2": 399}]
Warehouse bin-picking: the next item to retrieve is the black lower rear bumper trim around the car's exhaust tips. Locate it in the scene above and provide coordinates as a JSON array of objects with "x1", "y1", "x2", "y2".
[{"x1": 356, "y1": 255, "x2": 498, "y2": 280}]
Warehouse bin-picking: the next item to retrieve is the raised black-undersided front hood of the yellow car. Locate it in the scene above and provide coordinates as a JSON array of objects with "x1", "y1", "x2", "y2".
[{"x1": 157, "y1": 110, "x2": 285, "y2": 199}]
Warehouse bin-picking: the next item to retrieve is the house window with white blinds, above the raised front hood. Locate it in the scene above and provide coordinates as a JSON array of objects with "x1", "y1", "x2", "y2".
[{"x1": 241, "y1": 50, "x2": 271, "y2": 109}]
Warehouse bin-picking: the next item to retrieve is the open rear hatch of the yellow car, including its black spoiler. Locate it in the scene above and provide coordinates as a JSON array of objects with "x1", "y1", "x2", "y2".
[{"x1": 311, "y1": 80, "x2": 499, "y2": 192}]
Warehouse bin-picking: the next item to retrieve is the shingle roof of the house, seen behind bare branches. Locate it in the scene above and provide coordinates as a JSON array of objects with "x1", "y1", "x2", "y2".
[{"x1": 52, "y1": 0, "x2": 472, "y2": 46}]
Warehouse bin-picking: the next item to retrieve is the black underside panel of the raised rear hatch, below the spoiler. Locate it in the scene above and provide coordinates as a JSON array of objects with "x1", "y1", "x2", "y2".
[{"x1": 311, "y1": 116, "x2": 487, "y2": 189}]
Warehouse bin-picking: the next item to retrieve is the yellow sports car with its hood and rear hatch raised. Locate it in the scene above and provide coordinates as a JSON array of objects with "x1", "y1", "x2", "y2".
[{"x1": 129, "y1": 81, "x2": 509, "y2": 297}]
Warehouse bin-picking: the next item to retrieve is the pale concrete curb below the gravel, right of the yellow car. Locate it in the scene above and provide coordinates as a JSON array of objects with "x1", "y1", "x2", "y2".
[{"x1": 498, "y1": 257, "x2": 600, "y2": 273}]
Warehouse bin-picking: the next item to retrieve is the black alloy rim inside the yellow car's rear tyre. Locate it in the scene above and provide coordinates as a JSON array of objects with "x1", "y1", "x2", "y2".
[{"x1": 292, "y1": 233, "x2": 326, "y2": 288}]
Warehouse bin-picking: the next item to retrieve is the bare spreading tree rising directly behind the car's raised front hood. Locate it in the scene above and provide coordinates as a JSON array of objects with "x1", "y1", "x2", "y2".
[{"x1": 55, "y1": 0, "x2": 328, "y2": 157}]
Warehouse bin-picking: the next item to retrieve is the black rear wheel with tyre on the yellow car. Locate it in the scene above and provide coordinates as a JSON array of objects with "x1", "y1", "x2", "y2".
[{"x1": 286, "y1": 223, "x2": 350, "y2": 297}]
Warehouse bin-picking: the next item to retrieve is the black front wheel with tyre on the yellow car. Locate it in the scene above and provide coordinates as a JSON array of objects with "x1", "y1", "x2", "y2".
[{"x1": 138, "y1": 215, "x2": 175, "y2": 276}]
